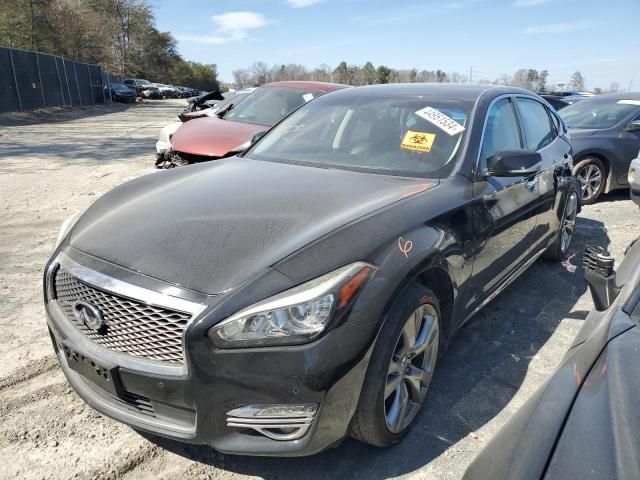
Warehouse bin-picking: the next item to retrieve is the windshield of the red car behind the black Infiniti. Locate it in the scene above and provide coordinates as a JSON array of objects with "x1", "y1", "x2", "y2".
[{"x1": 223, "y1": 87, "x2": 321, "y2": 127}]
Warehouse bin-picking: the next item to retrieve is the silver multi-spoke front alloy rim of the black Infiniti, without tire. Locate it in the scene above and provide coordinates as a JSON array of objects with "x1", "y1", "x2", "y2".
[{"x1": 384, "y1": 304, "x2": 440, "y2": 433}]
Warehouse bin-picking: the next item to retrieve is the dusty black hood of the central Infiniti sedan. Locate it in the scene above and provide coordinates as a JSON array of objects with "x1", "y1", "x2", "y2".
[{"x1": 69, "y1": 159, "x2": 435, "y2": 294}]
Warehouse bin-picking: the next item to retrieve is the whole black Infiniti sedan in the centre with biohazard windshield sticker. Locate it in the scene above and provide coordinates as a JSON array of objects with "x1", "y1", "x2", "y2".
[{"x1": 45, "y1": 84, "x2": 580, "y2": 455}]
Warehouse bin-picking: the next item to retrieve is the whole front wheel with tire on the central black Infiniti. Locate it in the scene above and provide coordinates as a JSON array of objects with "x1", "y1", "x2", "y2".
[{"x1": 352, "y1": 283, "x2": 441, "y2": 447}]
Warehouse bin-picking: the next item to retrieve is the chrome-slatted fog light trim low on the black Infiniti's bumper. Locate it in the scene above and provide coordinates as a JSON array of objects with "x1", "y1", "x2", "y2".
[{"x1": 227, "y1": 403, "x2": 318, "y2": 440}]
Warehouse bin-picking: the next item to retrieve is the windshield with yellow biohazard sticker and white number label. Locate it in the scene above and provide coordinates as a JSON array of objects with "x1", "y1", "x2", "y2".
[{"x1": 245, "y1": 95, "x2": 473, "y2": 178}]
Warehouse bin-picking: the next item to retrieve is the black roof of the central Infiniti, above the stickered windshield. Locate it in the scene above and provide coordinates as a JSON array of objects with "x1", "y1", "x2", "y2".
[{"x1": 322, "y1": 83, "x2": 535, "y2": 101}]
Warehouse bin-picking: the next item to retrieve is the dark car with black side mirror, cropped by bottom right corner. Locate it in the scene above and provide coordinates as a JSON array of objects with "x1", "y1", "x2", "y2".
[{"x1": 464, "y1": 235, "x2": 640, "y2": 480}]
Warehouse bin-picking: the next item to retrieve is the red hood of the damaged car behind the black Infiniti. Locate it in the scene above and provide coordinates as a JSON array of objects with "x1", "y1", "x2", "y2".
[{"x1": 171, "y1": 116, "x2": 269, "y2": 157}]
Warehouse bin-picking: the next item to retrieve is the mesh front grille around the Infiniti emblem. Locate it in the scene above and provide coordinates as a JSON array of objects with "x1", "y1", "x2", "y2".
[{"x1": 52, "y1": 265, "x2": 192, "y2": 363}]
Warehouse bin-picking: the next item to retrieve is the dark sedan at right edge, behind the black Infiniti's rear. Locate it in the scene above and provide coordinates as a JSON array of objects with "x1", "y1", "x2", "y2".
[{"x1": 560, "y1": 92, "x2": 640, "y2": 204}]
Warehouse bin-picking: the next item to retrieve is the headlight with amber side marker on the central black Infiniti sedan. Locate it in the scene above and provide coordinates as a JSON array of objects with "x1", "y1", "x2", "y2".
[{"x1": 209, "y1": 262, "x2": 375, "y2": 348}]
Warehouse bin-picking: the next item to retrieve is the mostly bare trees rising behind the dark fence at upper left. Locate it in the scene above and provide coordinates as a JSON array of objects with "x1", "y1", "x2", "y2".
[{"x1": 0, "y1": 0, "x2": 219, "y2": 90}]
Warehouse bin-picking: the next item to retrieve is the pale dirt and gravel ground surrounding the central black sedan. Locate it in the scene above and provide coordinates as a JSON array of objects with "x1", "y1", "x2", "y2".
[{"x1": 0, "y1": 100, "x2": 640, "y2": 479}]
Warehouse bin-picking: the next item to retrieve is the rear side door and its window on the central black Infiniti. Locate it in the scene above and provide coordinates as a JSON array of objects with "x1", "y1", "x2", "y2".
[{"x1": 515, "y1": 96, "x2": 571, "y2": 248}]
